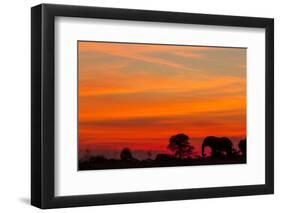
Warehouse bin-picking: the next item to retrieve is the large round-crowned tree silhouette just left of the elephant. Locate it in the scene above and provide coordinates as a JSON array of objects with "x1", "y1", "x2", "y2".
[{"x1": 167, "y1": 133, "x2": 194, "y2": 159}]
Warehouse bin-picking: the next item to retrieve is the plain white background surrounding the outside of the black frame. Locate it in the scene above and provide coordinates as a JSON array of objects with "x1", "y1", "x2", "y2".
[{"x1": 0, "y1": 0, "x2": 276, "y2": 213}]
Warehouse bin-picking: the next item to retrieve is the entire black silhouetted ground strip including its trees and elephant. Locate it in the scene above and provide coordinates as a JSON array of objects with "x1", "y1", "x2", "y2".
[{"x1": 78, "y1": 133, "x2": 246, "y2": 170}]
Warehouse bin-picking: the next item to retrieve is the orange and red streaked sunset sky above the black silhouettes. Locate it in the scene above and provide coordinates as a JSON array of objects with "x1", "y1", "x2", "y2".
[{"x1": 78, "y1": 41, "x2": 247, "y2": 158}]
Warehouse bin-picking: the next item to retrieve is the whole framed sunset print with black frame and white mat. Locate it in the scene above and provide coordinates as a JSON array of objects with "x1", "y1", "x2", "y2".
[{"x1": 31, "y1": 4, "x2": 274, "y2": 208}]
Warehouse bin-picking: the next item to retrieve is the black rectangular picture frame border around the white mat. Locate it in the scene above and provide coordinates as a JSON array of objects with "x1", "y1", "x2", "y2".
[{"x1": 31, "y1": 4, "x2": 274, "y2": 209}]
